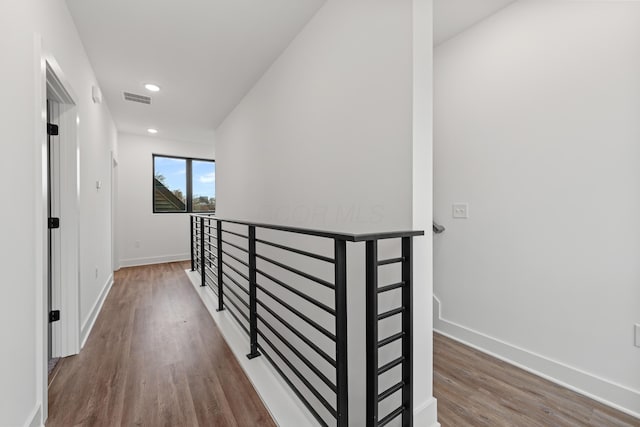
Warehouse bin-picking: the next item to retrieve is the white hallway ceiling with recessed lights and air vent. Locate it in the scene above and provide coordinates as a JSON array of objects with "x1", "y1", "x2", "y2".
[{"x1": 66, "y1": 0, "x2": 325, "y2": 142}]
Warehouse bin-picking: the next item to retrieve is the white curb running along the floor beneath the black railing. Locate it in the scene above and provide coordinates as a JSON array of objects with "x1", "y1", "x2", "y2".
[{"x1": 186, "y1": 270, "x2": 318, "y2": 427}]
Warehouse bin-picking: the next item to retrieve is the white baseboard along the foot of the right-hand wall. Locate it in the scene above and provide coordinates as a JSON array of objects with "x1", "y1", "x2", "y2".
[{"x1": 433, "y1": 296, "x2": 640, "y2": 418}]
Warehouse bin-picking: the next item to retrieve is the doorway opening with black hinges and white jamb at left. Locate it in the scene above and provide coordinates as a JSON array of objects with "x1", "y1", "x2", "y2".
[{"x1": 42, "y1": 58, "x2": 80, "y2": 420}]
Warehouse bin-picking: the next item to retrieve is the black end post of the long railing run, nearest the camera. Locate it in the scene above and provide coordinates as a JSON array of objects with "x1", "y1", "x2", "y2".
[{"x1": 334, "y1": 239, "x2": 349, "y2": 427}]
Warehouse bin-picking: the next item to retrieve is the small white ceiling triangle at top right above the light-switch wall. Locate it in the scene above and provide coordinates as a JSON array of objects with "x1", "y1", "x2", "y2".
[{"x1": 433, "y1": 0, "x2": 515, "y2": 46}]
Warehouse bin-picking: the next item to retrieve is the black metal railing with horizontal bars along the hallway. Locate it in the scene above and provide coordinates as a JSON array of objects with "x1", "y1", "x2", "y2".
[{"x1": 190, "y1": 215, "x2": 424, "y2": 427}]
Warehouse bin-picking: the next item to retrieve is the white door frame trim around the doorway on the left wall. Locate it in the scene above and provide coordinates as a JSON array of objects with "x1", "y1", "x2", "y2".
[{"x1": 34, "y1": 34, "x2": 80, "y2": 422}]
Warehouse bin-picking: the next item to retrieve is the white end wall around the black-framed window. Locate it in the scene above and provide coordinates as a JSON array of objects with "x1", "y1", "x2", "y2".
[{"x1": 116, "y1": 133, "x2": 215, "y2": 267}]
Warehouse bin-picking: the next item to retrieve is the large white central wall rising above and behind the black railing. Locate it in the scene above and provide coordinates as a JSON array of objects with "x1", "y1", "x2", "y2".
[{"x1": 216, "y1": 0, "x2": 435, "y2": 425}]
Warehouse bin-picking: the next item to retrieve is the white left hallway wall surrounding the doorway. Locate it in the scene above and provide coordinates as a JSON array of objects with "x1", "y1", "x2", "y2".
[{"x1": 0, "y1": 0, "x2": 116, "y2": 426}]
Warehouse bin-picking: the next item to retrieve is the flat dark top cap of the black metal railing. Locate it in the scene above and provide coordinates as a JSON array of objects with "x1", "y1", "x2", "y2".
[{"x1": 191, "y1": 214, "x2": 424, "y2": 242}]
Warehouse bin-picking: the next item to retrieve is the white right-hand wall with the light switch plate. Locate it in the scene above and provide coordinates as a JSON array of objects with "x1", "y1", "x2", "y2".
[{"x1": 434, "y1": 1, "x2": 640, "y2": 415}]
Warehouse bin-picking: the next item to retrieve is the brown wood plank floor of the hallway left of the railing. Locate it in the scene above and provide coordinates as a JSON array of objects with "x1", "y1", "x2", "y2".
[{"x1": 47, "y1": 263, "x2": 275, "y2": 427}]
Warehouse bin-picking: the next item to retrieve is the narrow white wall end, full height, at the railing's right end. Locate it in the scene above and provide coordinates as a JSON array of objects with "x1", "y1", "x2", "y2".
[{"x1": 412, "y1": 0, "x2": 437, "y2": 426}]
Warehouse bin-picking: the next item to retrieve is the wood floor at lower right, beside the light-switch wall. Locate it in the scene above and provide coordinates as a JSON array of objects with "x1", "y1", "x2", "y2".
[{"x1": 433, "y1": 333, "x2": 640, "y2": 427}]
